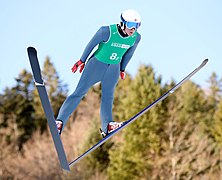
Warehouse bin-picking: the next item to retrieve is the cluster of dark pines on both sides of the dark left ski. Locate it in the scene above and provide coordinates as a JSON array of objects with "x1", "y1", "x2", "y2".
[{"x1": 0, "y1": 57, "x2": 68, "y2": 151}]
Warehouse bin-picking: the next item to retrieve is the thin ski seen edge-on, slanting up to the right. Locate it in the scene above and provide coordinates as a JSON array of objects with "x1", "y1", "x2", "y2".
[{"x1": 69, "y1": 59, "x2": 208, "y2": 166}]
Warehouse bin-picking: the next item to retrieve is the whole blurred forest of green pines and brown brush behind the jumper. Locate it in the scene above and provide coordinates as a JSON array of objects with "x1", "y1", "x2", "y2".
[{"x1": 0, "y1": 57, "x2": 222, "y2": 180}]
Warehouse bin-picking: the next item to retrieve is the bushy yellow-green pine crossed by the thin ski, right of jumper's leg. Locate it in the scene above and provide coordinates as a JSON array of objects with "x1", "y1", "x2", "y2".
[{"x1": 108, "y1": 66, "x2": 162, "y2": 179}]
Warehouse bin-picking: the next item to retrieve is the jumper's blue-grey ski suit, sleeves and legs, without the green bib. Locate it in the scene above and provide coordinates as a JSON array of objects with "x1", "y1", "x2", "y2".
[{"x1": 57, "y1": 26, "x2": 141, "y2": 132}]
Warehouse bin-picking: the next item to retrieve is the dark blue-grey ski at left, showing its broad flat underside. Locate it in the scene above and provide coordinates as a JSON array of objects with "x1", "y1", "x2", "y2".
[{"x1": 27, "y1": 47, "x2": 70, "y2": 171}]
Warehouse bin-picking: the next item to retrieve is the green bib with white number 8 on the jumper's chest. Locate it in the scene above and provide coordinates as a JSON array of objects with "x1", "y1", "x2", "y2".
[{"x1": 94, "y1": 24, "x2": 138, "y2": 64}]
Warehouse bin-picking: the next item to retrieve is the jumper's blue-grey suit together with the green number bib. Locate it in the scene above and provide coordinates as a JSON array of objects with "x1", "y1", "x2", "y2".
[{"x1": 57, "y1": 24, "x2": 141, "y2": 132}]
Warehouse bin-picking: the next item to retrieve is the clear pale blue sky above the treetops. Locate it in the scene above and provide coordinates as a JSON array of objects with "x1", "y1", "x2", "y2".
[{"x1": 0, "y1": 0, "x2": 222, "y2": 93}]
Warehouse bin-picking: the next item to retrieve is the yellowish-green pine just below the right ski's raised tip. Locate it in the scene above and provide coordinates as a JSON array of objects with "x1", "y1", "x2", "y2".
[{"x1": 165, "y1": 81, "x2": 213, "y2": 179}]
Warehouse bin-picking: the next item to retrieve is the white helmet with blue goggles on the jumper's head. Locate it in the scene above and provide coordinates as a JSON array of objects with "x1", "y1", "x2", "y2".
[{"x1": 120, "y1": 9, "x2": 141, "y2": 29}]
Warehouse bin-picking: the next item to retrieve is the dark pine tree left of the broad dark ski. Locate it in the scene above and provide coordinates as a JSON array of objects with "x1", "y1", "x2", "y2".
[{"x1": 1, "y1": 70, "x2": 36, "y2": 150}]
